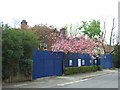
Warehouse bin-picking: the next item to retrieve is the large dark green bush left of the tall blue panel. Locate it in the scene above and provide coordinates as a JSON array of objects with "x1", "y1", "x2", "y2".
[{"x1": 2, "y1": 28, "x2": 39, "y2": 82}]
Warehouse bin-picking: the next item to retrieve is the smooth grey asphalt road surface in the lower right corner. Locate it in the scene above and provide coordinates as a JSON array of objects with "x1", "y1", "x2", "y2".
[{"x1": 53, "y1": 73, "x2": 120, "y2": 88}]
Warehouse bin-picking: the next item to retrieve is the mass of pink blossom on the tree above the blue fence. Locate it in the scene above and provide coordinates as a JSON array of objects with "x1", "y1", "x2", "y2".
[{"x1": 52, "y1": 36, "x2": 98, "y2": 54}]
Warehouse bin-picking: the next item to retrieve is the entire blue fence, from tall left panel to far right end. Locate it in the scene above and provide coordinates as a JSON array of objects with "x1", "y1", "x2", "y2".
[{"x1": 32, "y1": 50, "x2": 112, "y2": 79}]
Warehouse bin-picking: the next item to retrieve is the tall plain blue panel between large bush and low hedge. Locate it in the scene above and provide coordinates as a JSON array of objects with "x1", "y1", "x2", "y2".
[{"x1": 32, "y1": 50, "x2": 63, "y2": 79}]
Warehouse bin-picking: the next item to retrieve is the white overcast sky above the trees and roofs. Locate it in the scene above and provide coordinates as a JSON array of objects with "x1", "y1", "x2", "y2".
[{"x1": 0, "y1": 0, "x2": 119, "y2": 43}]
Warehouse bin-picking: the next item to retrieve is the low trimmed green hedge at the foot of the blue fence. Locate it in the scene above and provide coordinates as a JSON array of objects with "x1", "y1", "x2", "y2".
[{"x1": 65, "y1": 66, "x2": 102, "y2": 75}]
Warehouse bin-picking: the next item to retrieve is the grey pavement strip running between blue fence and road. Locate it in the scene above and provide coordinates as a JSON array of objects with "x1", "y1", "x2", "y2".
[{"x1": 2, "y1": 69, "x2": 118, "y2": 88}]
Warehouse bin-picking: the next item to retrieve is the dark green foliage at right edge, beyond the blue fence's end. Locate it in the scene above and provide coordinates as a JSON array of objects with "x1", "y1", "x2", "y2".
[{"x1": 113, "y1": 45, "x2": 120, "y2": 68}]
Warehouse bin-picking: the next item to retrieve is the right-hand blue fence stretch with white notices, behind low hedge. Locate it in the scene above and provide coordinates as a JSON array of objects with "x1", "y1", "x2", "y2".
[{"x1": 65, "y1": 53, "x2": 112, "y2": 69}]
